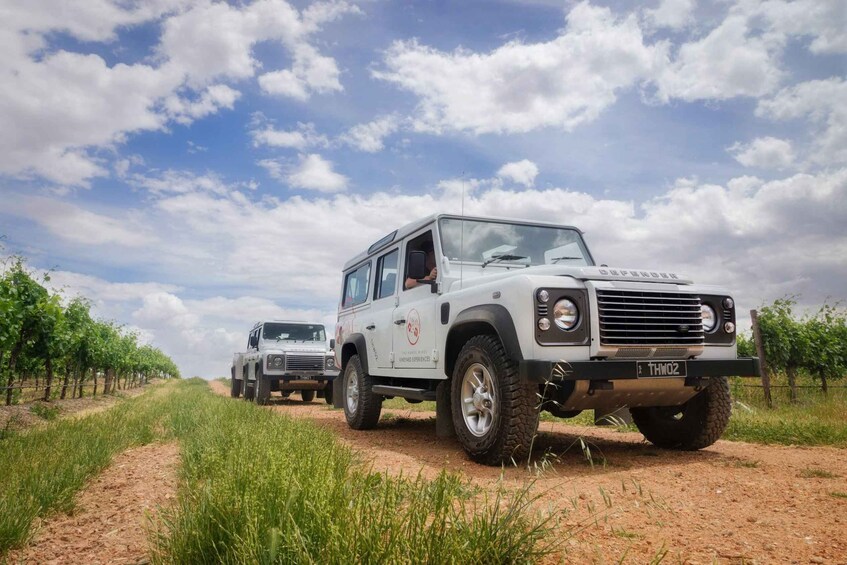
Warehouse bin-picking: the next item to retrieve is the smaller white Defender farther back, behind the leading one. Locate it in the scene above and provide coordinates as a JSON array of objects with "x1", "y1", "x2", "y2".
[{"x1": 230, "y1": 320, "x2": 338, "y2": 404}]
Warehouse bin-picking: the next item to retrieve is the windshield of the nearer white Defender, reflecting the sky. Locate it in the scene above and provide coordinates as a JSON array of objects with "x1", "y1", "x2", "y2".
[{"x1": 440, "y1": 218, "x2": 592, "y2": 266}]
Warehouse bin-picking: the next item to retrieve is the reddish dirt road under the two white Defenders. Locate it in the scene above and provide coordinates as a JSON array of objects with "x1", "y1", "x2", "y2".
[{"x1": 213, "y1": 382, "x2": 847, "y2": 563}]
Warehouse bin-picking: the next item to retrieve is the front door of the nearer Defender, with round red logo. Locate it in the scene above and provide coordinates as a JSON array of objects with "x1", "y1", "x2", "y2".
[{"x1": 392, "y1": 225, "x2": 441, "y2": 369}]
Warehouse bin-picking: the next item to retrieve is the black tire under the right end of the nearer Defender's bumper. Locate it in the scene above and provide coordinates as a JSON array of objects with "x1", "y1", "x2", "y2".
[{"x1": 630, "y1": 377, "x2": 732, "y2": 451}]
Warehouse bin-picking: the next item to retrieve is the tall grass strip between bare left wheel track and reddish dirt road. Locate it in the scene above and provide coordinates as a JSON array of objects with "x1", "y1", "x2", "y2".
[{"x1": 153, "y1": 382, "x2": 551, "y2": 563}]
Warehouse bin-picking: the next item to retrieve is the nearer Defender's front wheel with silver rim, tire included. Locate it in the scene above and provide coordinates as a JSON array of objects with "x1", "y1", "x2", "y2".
[{"x1": 450, "y1": 335, "x2": 538, "y2": 465}]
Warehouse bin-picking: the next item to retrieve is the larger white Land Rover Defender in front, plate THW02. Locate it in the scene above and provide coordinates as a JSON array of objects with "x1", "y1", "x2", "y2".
[{"x1": 334, "y1": 215, "x2": 758, "y2": 464}]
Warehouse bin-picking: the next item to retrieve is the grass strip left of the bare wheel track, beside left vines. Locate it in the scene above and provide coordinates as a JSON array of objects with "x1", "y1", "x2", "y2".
[{"x1": 0, "y1": 384, "x2": 167, "y2": 556}]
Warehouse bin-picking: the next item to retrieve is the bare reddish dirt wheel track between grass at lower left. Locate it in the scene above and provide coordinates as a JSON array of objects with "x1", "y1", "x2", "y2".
[{"x1": 7, "y1": 444, "x2": 179, "y2": 565}]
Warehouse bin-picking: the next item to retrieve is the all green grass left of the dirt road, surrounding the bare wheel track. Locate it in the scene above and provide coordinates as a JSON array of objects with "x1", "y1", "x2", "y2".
[{"x1": 0, "y1": 379, "x2": 560, "y2": 563}]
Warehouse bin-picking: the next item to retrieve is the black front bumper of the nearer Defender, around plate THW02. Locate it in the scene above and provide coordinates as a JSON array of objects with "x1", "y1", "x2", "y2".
[{"x1": 518, "y1": 357, "x2": 759, "y2": 383}]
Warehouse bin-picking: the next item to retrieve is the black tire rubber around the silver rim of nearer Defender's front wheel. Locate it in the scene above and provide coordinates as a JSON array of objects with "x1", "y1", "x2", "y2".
[{"x1": 450, "y1": 335, "x2": 539, "y2": 465}]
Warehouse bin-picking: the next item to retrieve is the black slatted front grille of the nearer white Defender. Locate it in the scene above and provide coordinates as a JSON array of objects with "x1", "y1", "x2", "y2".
[{"x1": 597, "y1": 289, "x2": 704, "y2": 346}]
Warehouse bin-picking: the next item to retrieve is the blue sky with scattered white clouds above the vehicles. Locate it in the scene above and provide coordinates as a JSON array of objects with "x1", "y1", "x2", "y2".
[{"x1": 0, "y1": 0, "x2": 847, "y2": 378}]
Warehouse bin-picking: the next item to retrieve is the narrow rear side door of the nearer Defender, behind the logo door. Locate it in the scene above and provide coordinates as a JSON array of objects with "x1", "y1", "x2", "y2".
[{"x1": 363, "y1": 247, "x2": 400, "y2": 372}]
